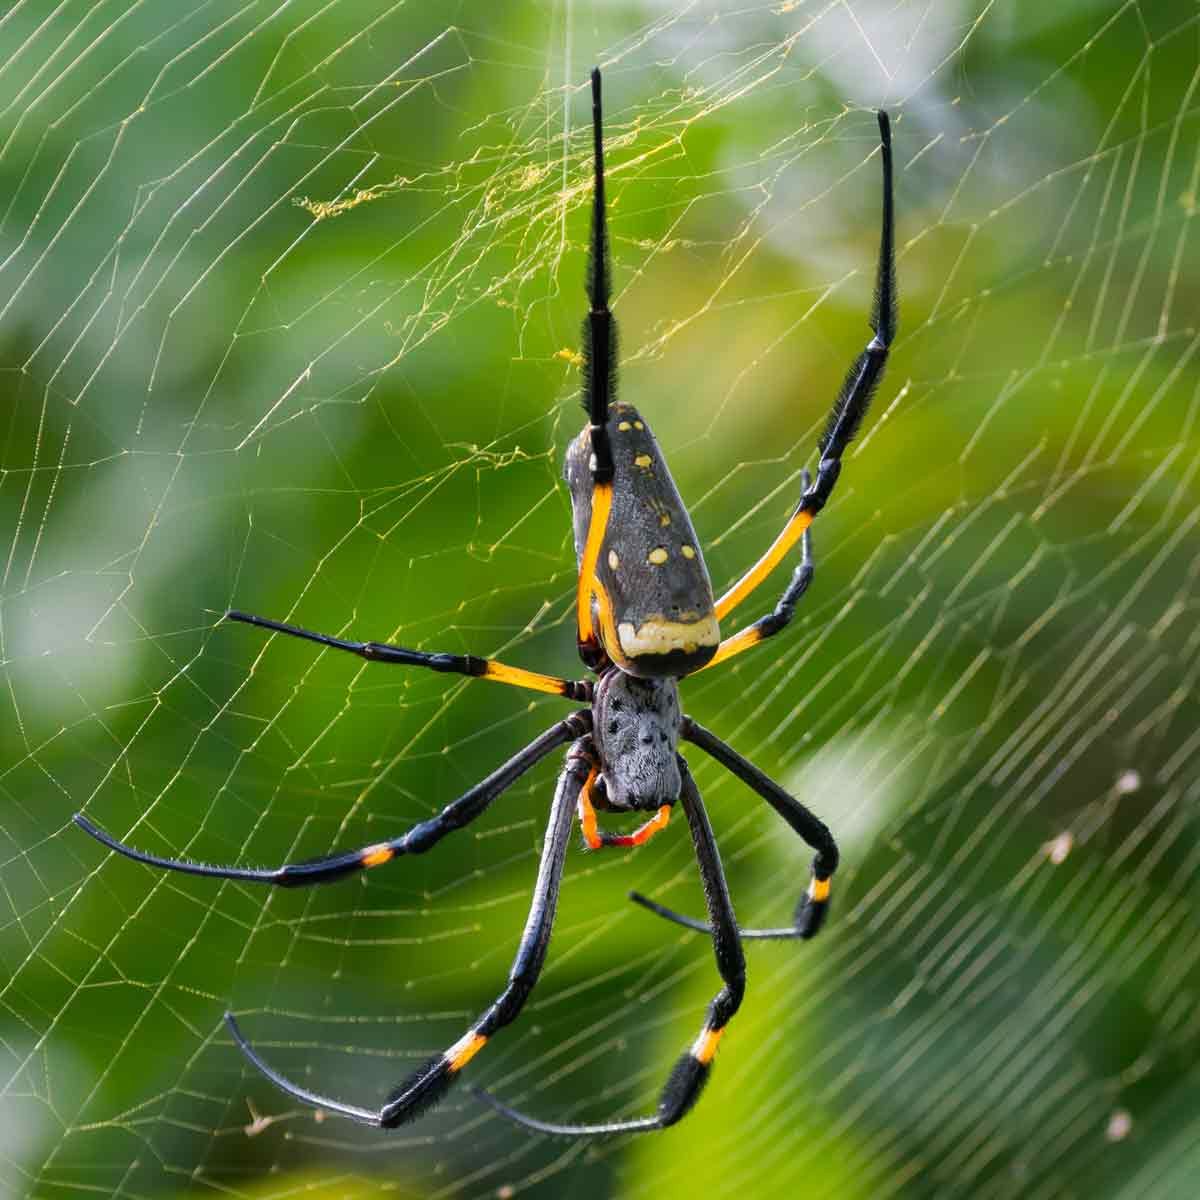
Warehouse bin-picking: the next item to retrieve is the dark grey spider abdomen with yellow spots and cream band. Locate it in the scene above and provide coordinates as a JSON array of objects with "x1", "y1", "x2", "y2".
[{"x1": 563, "y1": 403, "x2": 721, "y2": 678}]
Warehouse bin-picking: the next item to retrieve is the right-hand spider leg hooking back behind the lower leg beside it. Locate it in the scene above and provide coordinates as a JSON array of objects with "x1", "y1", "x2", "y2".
[{"x1": 629, "y1": 716, "x2": 839, "y2": 940}]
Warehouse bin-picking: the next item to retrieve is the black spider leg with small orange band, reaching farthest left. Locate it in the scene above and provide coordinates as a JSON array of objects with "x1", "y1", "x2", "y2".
[{"x1": 74, "y1": 709, "x2": 592, "y2": 888}]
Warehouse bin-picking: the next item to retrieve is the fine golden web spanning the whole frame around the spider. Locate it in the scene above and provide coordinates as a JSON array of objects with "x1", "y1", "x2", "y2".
[{"x1": 0, "y1": 0, "x2": 1200, "y2": 1198}]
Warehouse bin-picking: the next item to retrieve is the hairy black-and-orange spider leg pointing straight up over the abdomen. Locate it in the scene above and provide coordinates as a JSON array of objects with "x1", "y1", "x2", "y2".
[{"x1": 575, "y1": 67, "x2": 617, "y2": 668}]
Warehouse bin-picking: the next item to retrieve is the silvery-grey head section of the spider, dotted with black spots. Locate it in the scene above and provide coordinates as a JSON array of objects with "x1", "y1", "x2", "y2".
[{"x1": 592, "y1": 670, "x2": 683, "y2": 812}]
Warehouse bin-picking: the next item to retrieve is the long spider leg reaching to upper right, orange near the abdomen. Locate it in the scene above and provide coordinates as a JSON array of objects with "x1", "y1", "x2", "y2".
[{"x1": 709, "y1": 110, "x2": 896, "y2": 638}]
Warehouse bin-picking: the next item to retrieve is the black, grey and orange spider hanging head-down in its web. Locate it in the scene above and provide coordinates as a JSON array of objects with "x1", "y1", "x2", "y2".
[{"x1": 74, "y1": 70, "x2": 896, "y2": 1136}]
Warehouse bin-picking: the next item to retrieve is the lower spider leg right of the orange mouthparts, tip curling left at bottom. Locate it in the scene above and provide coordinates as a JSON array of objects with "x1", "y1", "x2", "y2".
[{"x1": 475, "y1": 756, "x2": 746, "y2": 1138}]
